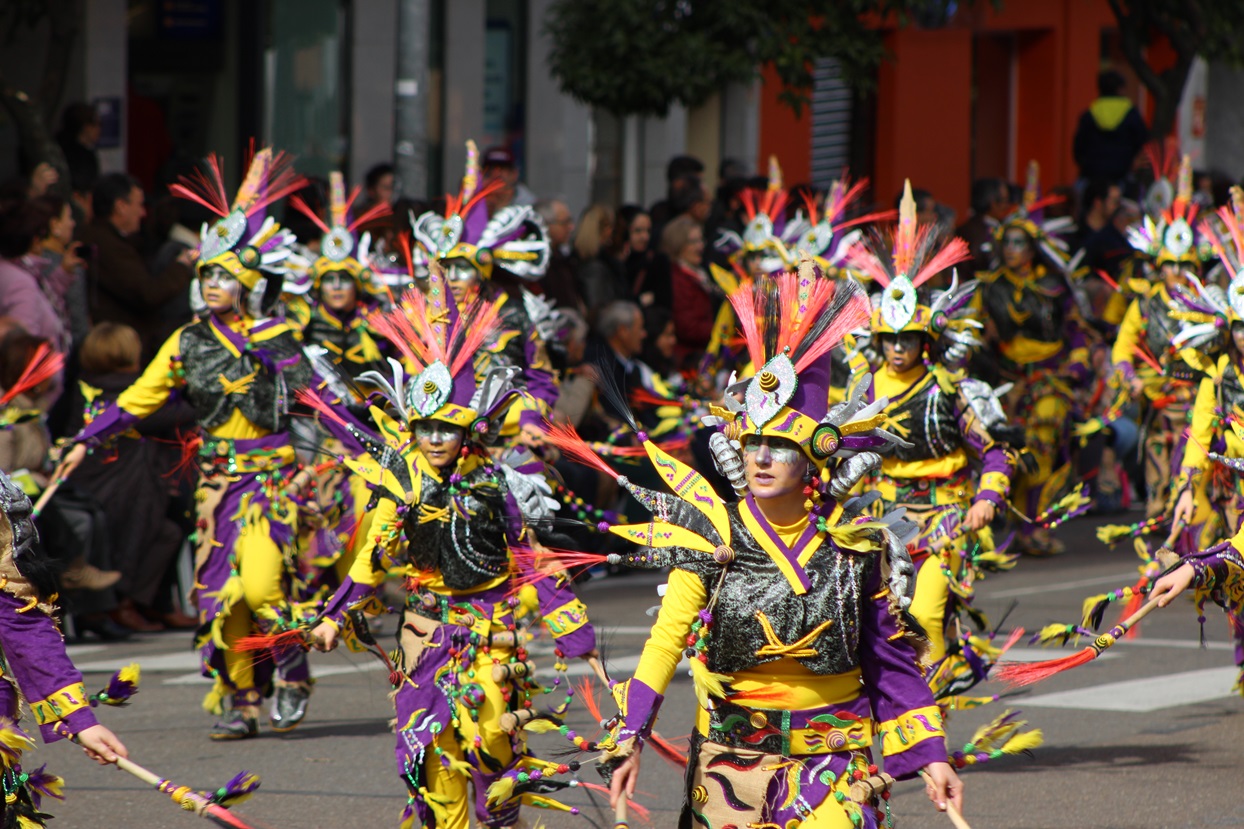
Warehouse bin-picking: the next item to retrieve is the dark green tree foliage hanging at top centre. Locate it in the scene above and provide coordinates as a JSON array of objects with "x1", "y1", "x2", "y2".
[{"x1": 545, "y1": 0, "x2": 957, "y2": 116}]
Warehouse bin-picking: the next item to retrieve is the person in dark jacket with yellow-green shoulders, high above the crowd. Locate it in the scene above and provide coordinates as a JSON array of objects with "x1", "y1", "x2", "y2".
[{"x1": 1074, "y1": 70, "x2": 1149, "y2": 182}]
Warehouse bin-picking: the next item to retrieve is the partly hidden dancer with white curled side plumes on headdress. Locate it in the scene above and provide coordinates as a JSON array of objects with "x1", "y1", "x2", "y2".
[{"x1": 411, "y1": 141, "x2": 557, "y2": 446}]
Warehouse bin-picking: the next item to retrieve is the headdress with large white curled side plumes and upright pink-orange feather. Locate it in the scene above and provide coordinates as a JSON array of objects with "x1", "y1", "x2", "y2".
[{"x1": 411, "y1": 141, "x2": 549, "y2": 281}]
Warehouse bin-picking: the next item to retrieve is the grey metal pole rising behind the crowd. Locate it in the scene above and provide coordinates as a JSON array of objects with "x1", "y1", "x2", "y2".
[{"x1": 393, "y1": 0, "x2": 432, "y2": 198}]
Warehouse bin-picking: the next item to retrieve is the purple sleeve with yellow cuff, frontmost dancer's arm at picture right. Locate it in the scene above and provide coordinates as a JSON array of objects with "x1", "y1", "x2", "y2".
[{"x1": 860, "y1": 557, "x2": 947, "y2": 779}]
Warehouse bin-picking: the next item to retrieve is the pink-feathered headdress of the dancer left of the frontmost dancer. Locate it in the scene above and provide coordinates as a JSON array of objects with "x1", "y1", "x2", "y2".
[{"x1": 360, "y1": 263, "x2": 504, "y2": 432}]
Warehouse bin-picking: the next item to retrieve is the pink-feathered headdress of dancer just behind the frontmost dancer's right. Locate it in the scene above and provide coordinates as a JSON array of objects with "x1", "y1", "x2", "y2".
[{"x1": 847, "y1": 180, "x2": 972, "y2": 336}]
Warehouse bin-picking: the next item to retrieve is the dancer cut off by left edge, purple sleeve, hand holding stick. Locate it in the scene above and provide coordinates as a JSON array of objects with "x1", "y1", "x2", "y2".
[{"x1": 0, "y1": 472, "x2": 128, "y2": 828}]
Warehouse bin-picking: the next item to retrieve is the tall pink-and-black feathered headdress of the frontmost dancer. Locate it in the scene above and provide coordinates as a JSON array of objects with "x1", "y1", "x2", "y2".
[{"x1": 714, "y1": 260, "x2": 868, "y2": 467}]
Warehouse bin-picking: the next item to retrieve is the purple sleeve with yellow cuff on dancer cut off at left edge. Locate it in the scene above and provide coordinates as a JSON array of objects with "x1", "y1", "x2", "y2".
[{"x1": 0, "y1": 592, "x2": 96, "y2": 743}]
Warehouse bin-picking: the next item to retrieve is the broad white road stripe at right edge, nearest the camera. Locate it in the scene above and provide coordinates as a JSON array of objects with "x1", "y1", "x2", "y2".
[{"x1": 1023, "y1": 666, "x2": 1239, "y2": 713}]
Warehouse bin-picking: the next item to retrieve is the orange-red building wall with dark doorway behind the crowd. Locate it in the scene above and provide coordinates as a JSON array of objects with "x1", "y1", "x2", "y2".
[{"x1": 756, "y1": 0, "x2": 1116, "y2": 220}]
